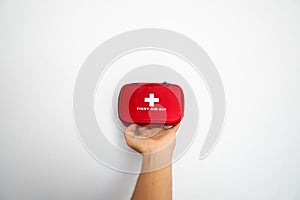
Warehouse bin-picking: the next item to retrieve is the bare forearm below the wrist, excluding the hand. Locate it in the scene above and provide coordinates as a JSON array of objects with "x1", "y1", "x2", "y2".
[{"x1": 132, "y1": 155, "x2": 172, "y2": 200}]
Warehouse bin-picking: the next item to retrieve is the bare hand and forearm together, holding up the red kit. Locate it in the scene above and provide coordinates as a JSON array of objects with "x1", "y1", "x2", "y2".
[{"x1": 124, "y1": 124, "x2": 180, "y2": 200}]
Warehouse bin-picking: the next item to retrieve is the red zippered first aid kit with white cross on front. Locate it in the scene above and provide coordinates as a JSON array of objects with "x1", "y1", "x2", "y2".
[{"x1": 118, "y1": 82, "x2": 184, "y2": 126}]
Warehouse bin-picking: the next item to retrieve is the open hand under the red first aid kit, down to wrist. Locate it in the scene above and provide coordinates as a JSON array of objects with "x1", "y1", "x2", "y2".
[{"x1": 124, "y1": 124, "x2": 180, "y2": 155}]
